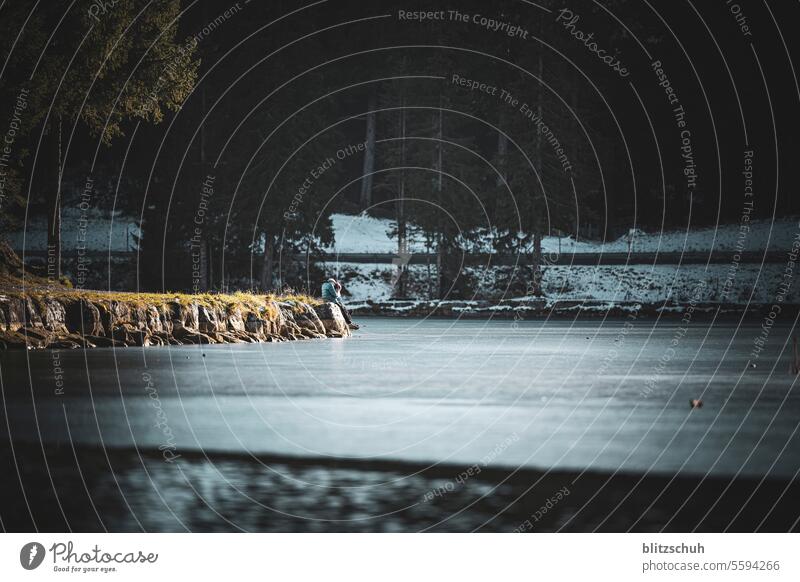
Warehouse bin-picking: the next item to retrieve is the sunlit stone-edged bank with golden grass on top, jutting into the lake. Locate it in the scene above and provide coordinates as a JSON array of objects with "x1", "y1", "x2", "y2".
[{"x1": 0, "y1": 288, "x2": 350, "y2": 349}]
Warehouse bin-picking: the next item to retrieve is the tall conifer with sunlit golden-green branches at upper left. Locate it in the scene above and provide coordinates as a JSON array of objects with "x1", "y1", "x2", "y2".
[{"x1": 0, "y1": 0, "x2": 199, "y2": 275}]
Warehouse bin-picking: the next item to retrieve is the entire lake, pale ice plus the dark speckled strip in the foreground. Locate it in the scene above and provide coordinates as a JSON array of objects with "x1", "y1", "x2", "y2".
[{"x1": 0, "y1": 319, "x2": 800, "y2": 531}]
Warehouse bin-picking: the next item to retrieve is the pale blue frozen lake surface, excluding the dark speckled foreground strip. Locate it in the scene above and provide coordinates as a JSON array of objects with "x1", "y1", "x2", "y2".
[{"x1": 0, "y1": 318, "x2": 800, "y2": 530}]
